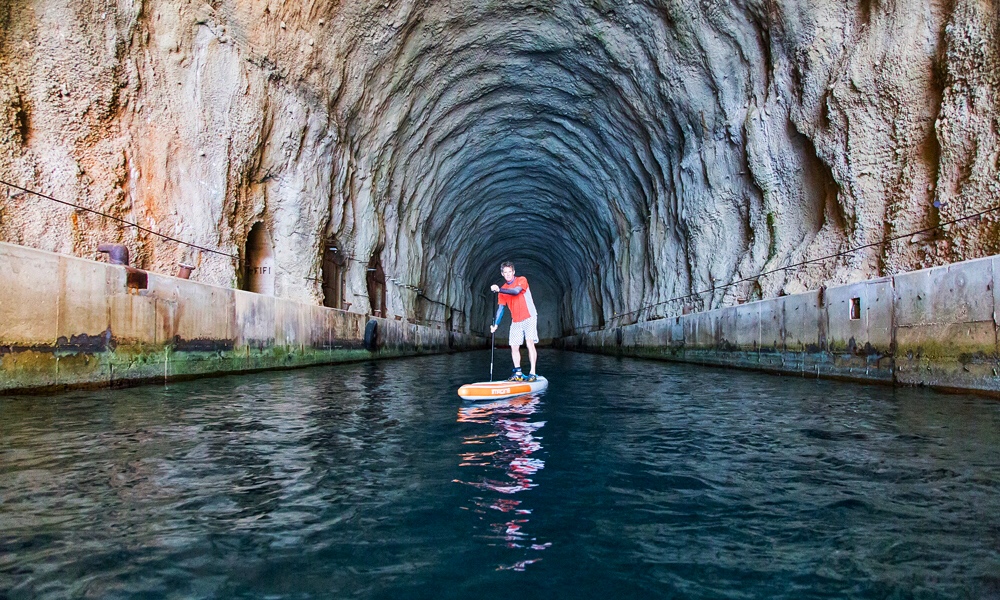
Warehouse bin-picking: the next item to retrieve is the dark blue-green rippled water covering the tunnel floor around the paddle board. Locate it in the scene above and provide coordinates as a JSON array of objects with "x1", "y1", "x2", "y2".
[{"x1": 0, "y1": 352, "x2": 1000, "y2": 600}]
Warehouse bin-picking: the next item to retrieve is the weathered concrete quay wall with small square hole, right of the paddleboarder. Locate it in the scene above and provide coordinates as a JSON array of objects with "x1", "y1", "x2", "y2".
[{"x1": 562, "y1": 256, "x2": 1000, "y2": 393}]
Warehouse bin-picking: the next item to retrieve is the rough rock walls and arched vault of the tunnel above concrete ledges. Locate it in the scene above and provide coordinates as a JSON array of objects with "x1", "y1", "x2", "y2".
[{"x1": 0, "y1": 0, "x2": 1000, "y2": 337}]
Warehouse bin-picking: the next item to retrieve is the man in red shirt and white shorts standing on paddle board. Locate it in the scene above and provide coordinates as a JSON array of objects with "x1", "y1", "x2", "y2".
[{"x1": 490, "y1": 261, "x2": 538, "y2": 381}]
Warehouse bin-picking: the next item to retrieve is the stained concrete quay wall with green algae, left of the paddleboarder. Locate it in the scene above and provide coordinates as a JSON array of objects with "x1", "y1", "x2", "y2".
[{"x1": 0, "y1": 243, "x2": 482, "y2": 392}]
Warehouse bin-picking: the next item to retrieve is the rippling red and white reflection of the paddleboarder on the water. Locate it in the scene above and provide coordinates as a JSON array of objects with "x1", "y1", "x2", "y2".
[{"x1": 455, "y1": 395, "x2": 552, "y2": 571}]
